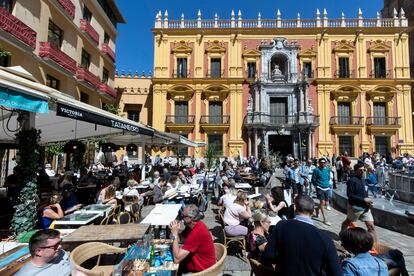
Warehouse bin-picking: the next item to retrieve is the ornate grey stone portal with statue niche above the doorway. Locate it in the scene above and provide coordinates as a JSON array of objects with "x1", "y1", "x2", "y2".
[{"x1": 246, "y1": 37, "x2": 318, "y2": 159}]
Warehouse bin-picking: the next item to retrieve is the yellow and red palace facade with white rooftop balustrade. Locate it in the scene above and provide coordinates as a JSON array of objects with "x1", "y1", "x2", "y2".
[{"x1": 153, "y1": 10, "x2": 414, "y2": 158}]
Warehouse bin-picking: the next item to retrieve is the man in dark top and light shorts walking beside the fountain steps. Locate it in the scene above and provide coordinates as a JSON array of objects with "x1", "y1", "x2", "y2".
[{"x1": 341, "y1": 163, "x2": 377, "y2": 241}]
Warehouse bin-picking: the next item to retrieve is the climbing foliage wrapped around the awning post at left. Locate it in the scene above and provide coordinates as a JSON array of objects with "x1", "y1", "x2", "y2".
[{"x1": 10, "y1": 129, "x2": 40, "y2": 236}]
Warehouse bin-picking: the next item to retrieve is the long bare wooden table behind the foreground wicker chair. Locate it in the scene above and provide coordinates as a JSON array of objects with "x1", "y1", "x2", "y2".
[{"x1": 62, "y1": 223, "x2": 150, "y2": 244}]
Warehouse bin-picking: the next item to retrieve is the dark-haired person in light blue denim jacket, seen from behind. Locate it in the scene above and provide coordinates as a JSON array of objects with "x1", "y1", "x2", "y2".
[{"x1": 340, "y1": 227, "x2": 388, "y2": 276}]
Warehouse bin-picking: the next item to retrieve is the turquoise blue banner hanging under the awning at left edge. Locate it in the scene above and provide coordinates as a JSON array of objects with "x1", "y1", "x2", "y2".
[{"x1": 0, "y1": 86, "x2": 49, "y2": 113}]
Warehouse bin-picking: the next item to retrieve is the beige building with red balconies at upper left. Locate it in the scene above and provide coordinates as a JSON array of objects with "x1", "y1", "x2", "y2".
[{"x1": 0, "y1": 0, "x2": 125, "y2": 108}]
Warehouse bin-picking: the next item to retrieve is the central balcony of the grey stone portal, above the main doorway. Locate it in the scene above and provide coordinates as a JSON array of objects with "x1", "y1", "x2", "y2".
[{"x1": 245, "y1": 112, "x2": 298, "y2": 127}]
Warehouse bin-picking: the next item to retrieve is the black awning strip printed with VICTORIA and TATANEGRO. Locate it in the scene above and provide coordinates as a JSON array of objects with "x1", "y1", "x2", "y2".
[{"x1": 56, "y1": 103, "x2": 154, "y2": 136}]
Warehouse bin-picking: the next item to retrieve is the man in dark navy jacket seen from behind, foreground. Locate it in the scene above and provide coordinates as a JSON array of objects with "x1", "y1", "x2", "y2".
[{"x1": 265, "y1": 195, "x2": 342, "y2": 276}]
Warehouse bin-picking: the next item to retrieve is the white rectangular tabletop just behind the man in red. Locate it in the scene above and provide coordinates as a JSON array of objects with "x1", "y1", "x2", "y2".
[{"x1": 141, "y1": 204, "x2": 182, "y2": 226}]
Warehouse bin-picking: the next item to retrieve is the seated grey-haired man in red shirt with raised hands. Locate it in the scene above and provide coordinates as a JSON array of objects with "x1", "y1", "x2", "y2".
[{"x1": 170, "y1": 204, "x2": 216, "y2": 272}]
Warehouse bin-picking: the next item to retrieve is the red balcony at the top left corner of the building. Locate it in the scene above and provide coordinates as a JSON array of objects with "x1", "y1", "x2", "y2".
[{"x1": 0, "y1": 7, "x2": 36, "y2": 49}]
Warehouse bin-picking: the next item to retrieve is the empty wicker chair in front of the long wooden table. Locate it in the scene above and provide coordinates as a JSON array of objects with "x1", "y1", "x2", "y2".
[{"x1": 70, "y1": 242, "x2": 127, "y2": 276}]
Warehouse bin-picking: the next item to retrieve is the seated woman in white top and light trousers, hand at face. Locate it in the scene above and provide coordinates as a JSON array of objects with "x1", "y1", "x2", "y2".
[{"x1": 223, "y1": 191, "x2": 252, "y2": 236}]
